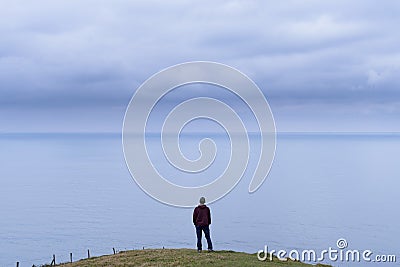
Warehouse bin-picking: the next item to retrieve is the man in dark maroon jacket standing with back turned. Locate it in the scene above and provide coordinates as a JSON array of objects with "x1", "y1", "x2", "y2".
[{"x1": 193, "y1": 197, "x2": 213, "y2": 252}]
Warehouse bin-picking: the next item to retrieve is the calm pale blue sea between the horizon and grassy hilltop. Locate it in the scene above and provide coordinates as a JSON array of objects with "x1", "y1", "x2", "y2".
[{"x1": 0, "y1": 134, "x2": 400, "y2": 266}]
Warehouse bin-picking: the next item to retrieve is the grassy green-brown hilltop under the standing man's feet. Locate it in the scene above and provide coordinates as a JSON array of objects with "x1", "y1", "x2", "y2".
[{"x1": 58, "y1": 249, "x2": 330, "y2": 267}]
